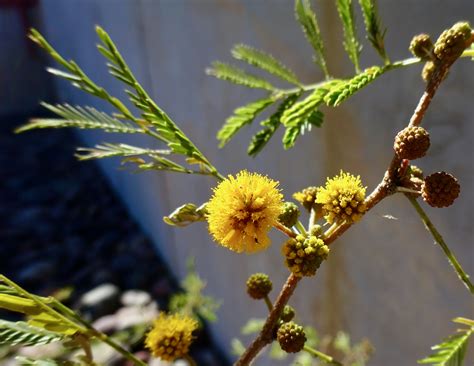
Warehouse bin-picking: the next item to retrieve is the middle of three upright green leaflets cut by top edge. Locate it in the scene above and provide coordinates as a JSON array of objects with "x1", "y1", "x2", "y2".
[{"x1": 336, "y1": 0, "x2": 362, "y2": 73}]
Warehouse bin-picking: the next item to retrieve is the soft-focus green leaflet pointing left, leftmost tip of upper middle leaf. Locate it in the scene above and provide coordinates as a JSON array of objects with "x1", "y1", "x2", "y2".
[{"x1": 206, "y1": 61, "x2": 275, "y2": 91}]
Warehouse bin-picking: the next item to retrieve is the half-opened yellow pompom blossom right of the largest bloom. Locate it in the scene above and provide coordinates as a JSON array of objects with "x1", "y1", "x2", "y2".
[{"x1": 316, "y1": 170, "x2": 367, "y2": 224}]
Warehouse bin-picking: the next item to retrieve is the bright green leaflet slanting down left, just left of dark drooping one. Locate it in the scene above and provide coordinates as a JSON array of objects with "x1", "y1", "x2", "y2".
[{"x1": 217, "y1": 97, "x2": 275, "y2": 147}]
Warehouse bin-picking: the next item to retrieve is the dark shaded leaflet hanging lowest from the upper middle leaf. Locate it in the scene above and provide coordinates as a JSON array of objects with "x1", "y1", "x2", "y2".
[{"x1": 247, "y1": 93, "x2": 301, "y2": 157}]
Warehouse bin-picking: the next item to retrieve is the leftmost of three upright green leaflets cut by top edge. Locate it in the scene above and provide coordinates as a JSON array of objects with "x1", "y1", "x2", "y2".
[{"x1": 295, "y1": 0, "x2": 330, "y2": 78}]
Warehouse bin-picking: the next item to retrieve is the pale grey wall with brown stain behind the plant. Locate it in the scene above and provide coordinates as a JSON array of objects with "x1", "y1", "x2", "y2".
[{"x1": 36, "y1": 0, "x2": 474, "y2": 366}]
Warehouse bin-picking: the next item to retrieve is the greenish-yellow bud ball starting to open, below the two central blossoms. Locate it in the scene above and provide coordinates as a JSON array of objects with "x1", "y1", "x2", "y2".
[{"x1": 282, "y1": 235, "x2": 329, "y2": 277}]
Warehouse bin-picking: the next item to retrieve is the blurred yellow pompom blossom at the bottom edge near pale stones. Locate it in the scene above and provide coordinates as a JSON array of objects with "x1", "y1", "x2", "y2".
[{"x1": 145, "y1": 313, "x2": 198, "y2": 361}]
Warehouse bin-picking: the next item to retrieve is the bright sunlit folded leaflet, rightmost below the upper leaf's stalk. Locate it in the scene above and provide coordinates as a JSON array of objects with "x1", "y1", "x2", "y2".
[{"x1": 324, "y1": 66, "x2": 386, "y2": 107}]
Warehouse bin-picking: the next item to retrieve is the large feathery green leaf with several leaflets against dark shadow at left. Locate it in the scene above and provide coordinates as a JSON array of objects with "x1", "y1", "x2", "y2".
[{"x1": 22, "y1": 27, "x2": 222, "y2": 179}]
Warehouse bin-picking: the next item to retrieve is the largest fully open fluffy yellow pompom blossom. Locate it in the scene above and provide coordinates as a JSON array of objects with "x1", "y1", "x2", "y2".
[{"x1": 207, "y1": 170, "x2": 283, "y2": 253}]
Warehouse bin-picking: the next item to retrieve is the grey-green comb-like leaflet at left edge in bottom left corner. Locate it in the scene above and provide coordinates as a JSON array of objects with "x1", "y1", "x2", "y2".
[{"x1": 0, "y1": 319, "x2": 64, "y2": 346}]
